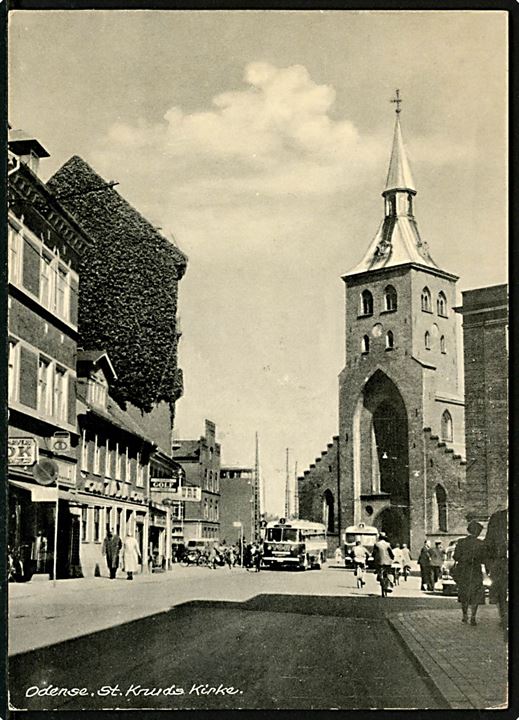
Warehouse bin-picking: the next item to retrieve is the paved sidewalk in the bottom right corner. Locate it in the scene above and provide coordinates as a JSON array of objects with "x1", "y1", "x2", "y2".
[{"x1": 389, "y1": 605, "x2": 508, "y2": 710}]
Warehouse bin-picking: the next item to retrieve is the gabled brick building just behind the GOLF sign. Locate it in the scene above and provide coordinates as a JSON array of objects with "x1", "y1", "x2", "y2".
[{"x1": 173, "y1": 420, "x2": 222, "y2": 542}]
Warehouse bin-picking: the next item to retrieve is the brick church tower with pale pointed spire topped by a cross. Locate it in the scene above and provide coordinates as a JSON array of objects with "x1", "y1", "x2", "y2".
[{"x1": 339, "y1": 91, "x2": 466, "y2": 552}]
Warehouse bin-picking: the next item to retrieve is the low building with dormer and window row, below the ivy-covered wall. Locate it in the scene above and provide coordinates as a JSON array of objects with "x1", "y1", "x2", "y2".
[{"x1": 75, "y1": 351, "x2": 156, "y2": 577}]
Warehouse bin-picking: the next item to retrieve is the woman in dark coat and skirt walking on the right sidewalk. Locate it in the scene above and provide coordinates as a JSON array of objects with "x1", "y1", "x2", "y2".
[{"x1": 451, "y1": 520, "x2": 485, "y2": 625}]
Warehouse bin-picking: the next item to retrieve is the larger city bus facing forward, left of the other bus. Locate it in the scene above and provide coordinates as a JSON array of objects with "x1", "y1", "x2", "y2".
[{"x1": 263, "y1": 518, "x2": 328, "y2": 570}]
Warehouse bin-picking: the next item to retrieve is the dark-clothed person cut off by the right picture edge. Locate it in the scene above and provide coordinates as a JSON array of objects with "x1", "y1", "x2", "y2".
[{"x1": 484, "y1": 508, "x2": 508, "y2": 641}]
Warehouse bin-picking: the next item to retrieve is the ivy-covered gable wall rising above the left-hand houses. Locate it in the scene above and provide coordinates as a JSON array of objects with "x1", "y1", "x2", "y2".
[{"x1": 48, "y1": 156, "x2": 187, "y2": 418}]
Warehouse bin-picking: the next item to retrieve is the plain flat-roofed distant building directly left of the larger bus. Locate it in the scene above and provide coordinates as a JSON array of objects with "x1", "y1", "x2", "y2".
[{"x1": 220, "y1": 466, "x2": 254, "y2": 544}]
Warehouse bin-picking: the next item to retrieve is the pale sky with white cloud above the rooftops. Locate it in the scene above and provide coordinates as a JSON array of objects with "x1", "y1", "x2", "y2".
[{"x1": 8, "y1": 10, "x2": 508, "y2": 514}]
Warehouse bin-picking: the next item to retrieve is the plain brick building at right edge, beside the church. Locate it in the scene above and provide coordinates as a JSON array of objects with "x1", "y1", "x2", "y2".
[{"x1": 456, "y1": 285, "x2": 508, "y2": 520}]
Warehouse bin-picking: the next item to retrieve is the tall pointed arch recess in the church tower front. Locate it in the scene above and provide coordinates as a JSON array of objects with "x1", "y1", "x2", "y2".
[{"x1": 353, "y1": 370, "x2": 410, "y2": 545}]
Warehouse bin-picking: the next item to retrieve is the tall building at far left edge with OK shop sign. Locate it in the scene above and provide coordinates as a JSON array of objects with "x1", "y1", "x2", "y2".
[{"x1": 8, "y1": 131, "x2": 90, "y2": 577}]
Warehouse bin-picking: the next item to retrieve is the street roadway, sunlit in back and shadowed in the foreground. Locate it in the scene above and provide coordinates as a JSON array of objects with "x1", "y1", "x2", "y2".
[{"x1": 10, "y1": 566, "x2": 506, "y2": 710}]
